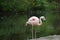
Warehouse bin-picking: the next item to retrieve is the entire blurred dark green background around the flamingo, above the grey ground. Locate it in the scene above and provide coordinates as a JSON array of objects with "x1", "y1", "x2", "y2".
[{"x1": 0, "y1": 0, "x2": 60, "y2": 40}]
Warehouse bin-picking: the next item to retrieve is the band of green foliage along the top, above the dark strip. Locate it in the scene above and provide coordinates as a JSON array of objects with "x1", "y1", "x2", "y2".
[{"x1": 0, "y1": 0, "x2": 56, "y2": 11}]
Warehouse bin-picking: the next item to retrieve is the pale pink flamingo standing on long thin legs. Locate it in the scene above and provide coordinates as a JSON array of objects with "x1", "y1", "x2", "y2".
[{"x1": 26, "y1": 16, "x2": 46, "y2": 39}]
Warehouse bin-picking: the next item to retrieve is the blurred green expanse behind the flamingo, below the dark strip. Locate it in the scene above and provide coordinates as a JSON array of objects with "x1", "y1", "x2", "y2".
[{"x1": 0, "y1": 13, "x2": 58, "y2": 40}]
